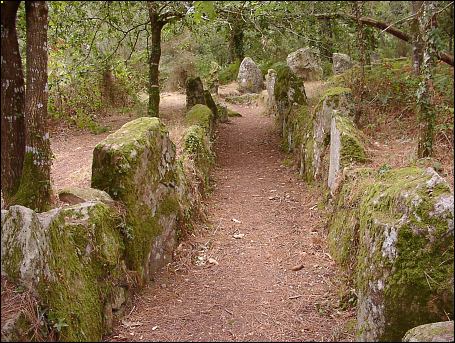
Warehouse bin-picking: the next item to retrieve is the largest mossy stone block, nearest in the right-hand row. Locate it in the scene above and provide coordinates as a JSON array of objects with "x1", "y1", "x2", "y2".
[{"x1": 329, "y1": 167, "x2": 454, "y2": 341}]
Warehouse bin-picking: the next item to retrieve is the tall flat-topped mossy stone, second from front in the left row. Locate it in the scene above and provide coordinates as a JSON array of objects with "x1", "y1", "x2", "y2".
[{"x1": 92, "y1": 117, "x2": 179, "y2": 281}]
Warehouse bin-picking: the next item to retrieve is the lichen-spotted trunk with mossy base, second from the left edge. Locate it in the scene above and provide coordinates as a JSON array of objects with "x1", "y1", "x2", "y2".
[{"x1": 15, "y1": 1, "x2": 51, "y2": 211}]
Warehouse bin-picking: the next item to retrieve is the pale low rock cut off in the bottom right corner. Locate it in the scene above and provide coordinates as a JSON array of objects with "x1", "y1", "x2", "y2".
[{"x1": 402, "y1": 320, "x2": 454, "y2": 342}]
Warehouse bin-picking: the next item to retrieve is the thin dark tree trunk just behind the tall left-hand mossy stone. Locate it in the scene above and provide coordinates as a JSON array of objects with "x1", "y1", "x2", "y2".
[{"x1": 147, "y1": 1, "x2": 163, "y2": 117}]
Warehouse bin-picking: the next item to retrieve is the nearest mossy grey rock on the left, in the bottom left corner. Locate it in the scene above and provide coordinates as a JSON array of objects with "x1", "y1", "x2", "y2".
[{"x1": 2, "y1": 202, "x2": 124, "y2": 341}]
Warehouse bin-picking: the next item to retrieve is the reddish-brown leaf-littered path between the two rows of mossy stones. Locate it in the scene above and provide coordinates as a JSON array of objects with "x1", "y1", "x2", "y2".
[{"x1": 106, "y1": 85, "x2": 352, "y2": 341}]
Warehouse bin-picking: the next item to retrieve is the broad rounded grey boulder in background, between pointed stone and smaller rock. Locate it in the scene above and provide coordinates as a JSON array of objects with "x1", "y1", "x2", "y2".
[{"x1": 286, "y1": 48, "x2": 322, "y2": 81}]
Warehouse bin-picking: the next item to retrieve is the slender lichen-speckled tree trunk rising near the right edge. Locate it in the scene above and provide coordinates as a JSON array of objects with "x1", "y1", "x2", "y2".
[{"x1": 417, "y1": 1, "x2": 437, "y2": 158}]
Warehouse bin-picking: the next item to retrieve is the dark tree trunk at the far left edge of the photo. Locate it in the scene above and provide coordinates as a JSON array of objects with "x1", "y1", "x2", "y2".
[{"x1": 1, "y1": 1, "x2": 25, "y2": 206}]
